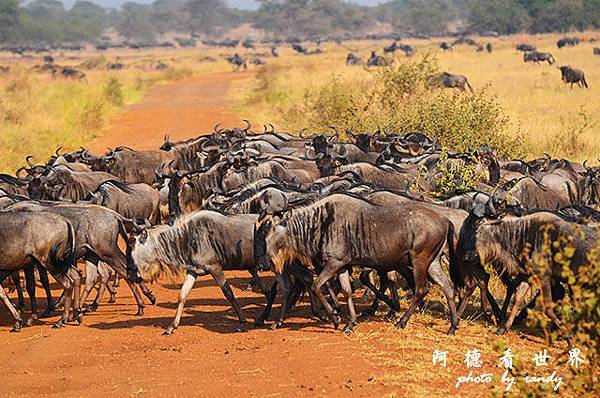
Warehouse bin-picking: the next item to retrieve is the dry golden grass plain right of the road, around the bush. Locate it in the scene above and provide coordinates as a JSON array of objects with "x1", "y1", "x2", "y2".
[{"x1": 232, "y1": 33, "x2": 600, "y2": 160}]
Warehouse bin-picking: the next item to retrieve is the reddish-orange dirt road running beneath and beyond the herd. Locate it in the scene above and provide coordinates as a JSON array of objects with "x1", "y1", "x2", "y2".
[{"x1": 0, "y1": 73, "x2": 552, "y2": 397}]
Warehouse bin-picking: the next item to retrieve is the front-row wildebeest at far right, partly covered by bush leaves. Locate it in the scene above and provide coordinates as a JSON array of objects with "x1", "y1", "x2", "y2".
[{"x1": 456, "y1": 206, "x2": 598, "y2": 334}]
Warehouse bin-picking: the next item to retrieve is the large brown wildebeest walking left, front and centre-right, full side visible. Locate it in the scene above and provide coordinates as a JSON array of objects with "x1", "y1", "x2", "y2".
[{"x1": 257, "y1": 194, "x2": 458, "y2": 334}]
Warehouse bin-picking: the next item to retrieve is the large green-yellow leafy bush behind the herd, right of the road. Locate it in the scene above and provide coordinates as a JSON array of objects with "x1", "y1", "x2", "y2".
[{"x1": 288, "y1": 54, "x2": 528, "y2": 156}]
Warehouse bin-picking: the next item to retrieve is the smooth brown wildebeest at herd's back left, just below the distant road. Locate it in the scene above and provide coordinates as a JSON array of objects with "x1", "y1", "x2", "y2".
[{"x1": 92, "y1": 147, "x2": 173, "y2": 185}]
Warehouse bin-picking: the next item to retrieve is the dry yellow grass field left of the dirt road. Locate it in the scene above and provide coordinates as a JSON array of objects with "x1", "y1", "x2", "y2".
[{"x1": 0, "y1": 46, "x2": 228, "y2": 172}]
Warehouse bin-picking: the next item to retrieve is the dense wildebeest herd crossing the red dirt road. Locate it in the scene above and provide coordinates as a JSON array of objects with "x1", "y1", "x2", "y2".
[{"x1": 0, "y1": 123, "x2": 600, "y2": 334}]
